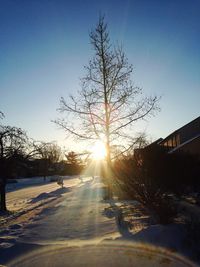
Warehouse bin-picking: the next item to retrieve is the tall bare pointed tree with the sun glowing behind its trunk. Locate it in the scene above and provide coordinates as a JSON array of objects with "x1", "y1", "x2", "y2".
[{"x1": 55, "y1": 17, "x2": 158, "y2": 195}]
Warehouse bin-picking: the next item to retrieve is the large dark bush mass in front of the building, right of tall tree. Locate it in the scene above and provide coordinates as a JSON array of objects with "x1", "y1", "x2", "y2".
[{"x1": 114, "y1": 145, "x2": 200, "y2": 223}]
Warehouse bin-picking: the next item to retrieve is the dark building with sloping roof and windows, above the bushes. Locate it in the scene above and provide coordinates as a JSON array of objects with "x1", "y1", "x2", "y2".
[{"x1": 158, "y1": 116, "x2": 200, "y2": 156}]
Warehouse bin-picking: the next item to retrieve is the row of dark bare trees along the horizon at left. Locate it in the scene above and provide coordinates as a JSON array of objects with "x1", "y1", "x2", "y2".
[{"x1": 0, "y1": 112, "x2": 83, "y2": 211}]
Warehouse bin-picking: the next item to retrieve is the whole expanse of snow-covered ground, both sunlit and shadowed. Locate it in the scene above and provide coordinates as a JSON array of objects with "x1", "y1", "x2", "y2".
[{"x1": 0, "y1": 177, "x2": 198, "y2": 266}]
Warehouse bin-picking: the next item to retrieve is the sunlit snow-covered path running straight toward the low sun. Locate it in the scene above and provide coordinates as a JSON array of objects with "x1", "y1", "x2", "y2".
[{"x1": 19, "y1": 178, "x2": 117, "y2": 244}]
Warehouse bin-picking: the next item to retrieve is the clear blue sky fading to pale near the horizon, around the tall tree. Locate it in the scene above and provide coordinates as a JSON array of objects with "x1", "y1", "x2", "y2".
[{"x1": 0, "y1": 0, "x2": 200, "y2": 151}]
